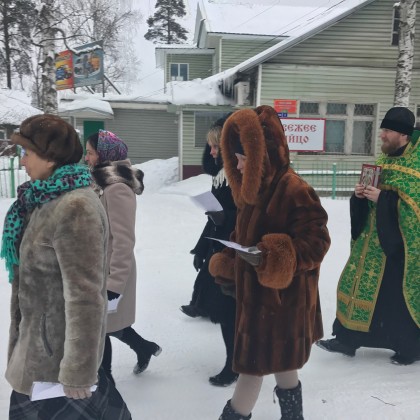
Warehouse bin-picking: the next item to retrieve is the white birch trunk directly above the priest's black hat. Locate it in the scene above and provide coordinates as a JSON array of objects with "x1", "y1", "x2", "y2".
[{"x1": 394, "y1": 0, "x2": 417, "y2": 107}]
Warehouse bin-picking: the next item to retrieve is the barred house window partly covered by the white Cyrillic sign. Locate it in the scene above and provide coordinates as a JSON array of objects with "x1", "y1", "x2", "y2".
[{"x1": 299, "y1": 102, "x2": 376, "y2": 156}]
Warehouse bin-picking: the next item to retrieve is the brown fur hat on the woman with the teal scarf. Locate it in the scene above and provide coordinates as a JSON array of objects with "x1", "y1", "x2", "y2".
[{"x1": 11, "y1": 114, "x2": 83, "y2": 166}]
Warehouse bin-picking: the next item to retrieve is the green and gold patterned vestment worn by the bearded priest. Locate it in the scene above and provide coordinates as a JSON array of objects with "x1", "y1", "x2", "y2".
[{"x1": 337, "y1": 141, "x2": 420, "y2": 332}]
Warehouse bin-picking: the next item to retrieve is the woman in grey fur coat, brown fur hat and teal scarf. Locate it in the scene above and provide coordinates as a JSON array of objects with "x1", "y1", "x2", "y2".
[{"x1": 1, "y1": 114, "x2": 131, "y2": 420}]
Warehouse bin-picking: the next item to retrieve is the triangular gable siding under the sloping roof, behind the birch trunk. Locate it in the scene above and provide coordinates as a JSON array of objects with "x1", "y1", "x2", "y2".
[{"x1": 271, "y1": 0, "x2": 420, "y2": 69}]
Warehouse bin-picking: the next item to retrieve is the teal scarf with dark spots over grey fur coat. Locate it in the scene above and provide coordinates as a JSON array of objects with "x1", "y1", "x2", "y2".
[{"x1": 0, "y1": 164, "x2": 92, "y2": 283}]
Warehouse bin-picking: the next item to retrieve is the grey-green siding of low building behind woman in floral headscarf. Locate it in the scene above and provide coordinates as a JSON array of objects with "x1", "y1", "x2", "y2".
[{"x1": 105, "y1": 109, "x2": 178, "y2": 163}]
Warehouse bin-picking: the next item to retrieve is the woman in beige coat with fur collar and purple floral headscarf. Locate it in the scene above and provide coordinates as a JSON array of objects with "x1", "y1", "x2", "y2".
[{"x1": 85, "y1": 130, "x2": 162, "y2": 380}]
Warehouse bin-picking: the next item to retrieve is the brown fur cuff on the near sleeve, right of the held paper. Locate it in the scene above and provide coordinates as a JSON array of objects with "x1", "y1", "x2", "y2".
[{"x1": 255, "y1": 233, "x2": 297, "y2": 289}]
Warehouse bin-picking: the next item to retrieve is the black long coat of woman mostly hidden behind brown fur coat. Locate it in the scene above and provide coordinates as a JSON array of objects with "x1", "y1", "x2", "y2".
[{"x1": 191, "y1": 145, "x2": 236, "y2": 323}]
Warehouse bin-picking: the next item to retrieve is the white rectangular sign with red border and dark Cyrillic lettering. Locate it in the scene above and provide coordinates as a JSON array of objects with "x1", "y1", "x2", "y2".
[{"x1": 279, "y1": 115, "x2": 325, "y2": 152}]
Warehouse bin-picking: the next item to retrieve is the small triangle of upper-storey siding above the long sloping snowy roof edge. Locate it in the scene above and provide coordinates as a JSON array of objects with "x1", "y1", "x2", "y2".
[{"x1": 220, "y1": 39, "x2": 278, "y2": 71}]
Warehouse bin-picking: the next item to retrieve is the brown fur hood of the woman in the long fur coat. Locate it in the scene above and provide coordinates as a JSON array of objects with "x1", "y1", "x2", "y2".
[{"x1": 221, "y1": 105, "x2": 290, "y2": 207}]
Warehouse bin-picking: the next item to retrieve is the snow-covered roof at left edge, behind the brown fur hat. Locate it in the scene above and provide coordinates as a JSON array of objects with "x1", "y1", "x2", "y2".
[{"x1": 0, "y1": 89, "x2": 42, "y2": 126}]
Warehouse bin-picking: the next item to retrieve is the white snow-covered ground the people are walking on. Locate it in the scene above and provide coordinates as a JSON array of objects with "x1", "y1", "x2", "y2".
[{"x1": 0, "y1": 158, "x2": 420, "y2": 420}]
